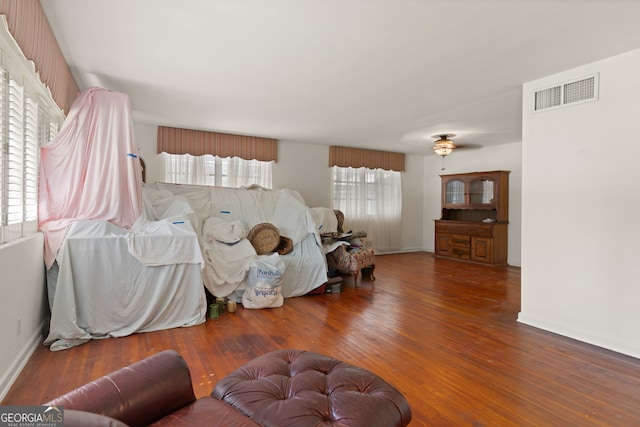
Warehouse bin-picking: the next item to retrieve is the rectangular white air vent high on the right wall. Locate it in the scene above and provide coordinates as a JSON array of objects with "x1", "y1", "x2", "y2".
[{"x1": 533, "y1": 74, "x2": 599, "y2": 111}]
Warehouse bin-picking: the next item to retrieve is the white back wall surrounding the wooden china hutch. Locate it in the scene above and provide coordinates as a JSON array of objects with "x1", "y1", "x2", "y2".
[{"x1": 423, "y1": 141, "x2": 522, "y2": 266}]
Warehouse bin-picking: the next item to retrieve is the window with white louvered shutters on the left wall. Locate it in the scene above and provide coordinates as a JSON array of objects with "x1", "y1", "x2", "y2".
[{"x1": 0, "y1": 32, "x2": 64, "y2": 244}]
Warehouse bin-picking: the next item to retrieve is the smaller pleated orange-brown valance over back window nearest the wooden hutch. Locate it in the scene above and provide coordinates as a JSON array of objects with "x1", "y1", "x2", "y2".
[{"x1": 329, "y1": 145, "x2": 404, "y2": 172}]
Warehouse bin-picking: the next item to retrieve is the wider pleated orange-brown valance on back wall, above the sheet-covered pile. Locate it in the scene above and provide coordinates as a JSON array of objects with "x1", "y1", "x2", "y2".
[{"x1": 158, "y1": 126, "x2": 278, "y2": 162}]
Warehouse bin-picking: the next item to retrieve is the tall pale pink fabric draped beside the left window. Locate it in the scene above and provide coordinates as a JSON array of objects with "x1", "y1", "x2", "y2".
[{"x1": 38, "y1": 88, "x2": 142, "y2": 268}]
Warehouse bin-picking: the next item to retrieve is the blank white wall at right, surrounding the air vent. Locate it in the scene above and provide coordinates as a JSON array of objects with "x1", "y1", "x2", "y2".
[{"x1": 518, "y1": 50, "x2": 640, "y2": 357}]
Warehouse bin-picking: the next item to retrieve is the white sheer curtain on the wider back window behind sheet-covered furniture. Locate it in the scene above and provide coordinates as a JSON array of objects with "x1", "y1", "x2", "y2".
[{"x1": 160, "y1": 153, "x2": 273, "y2": 188}]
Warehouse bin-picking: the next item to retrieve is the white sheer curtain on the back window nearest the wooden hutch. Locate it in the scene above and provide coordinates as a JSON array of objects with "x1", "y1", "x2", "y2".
[{"x1": 331, "y1": 166, "x2": 402, "y2": 251}]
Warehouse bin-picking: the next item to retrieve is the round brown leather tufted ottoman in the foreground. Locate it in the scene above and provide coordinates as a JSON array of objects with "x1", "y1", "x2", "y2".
[{"x1": 211, "y1": 350, "x2": 411, "y2": 427}]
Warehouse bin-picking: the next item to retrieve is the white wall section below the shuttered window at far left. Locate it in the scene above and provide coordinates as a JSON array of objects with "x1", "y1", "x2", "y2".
[{"x1": 0, "y1": 233, "x2": 48, "y2": 405}]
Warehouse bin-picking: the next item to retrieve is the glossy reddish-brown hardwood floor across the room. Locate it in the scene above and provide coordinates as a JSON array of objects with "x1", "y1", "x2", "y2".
[{"x1": 2, "y1": 253, "x2": 640, "y2": 427}]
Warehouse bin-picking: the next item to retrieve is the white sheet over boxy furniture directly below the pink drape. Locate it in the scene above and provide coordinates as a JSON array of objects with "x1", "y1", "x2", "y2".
[{"x1": 45, "y1": 216, "x2": 207, "y2": 350}]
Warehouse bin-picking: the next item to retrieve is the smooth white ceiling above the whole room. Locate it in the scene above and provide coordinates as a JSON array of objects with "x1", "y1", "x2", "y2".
[{"x1": 41, "y1": 0, "x2": 640, "y2": 154}]
